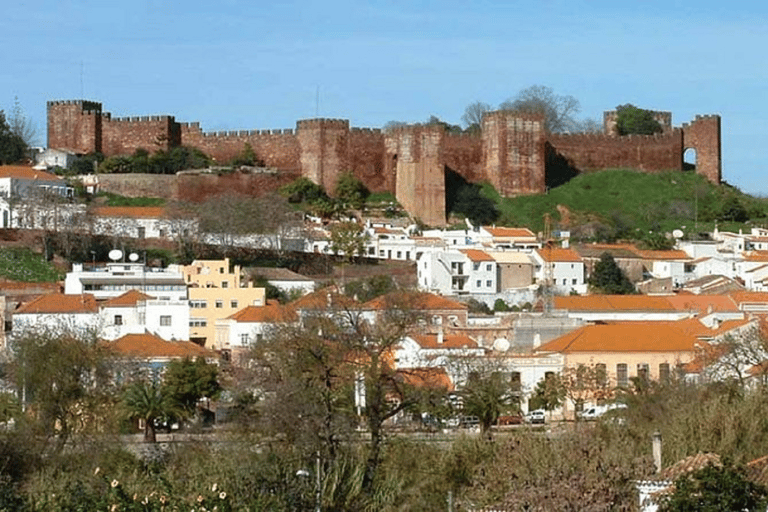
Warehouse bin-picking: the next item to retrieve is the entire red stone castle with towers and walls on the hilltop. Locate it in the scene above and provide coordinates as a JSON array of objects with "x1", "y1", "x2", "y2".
[{"x1": 48, "y1": 100, "x2": 722, "y2": 225}]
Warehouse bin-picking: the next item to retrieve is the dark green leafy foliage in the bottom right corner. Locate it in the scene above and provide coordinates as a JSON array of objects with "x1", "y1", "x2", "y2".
[{"x1": 660, "y1": 465, "x2": 768, "y2": 512}]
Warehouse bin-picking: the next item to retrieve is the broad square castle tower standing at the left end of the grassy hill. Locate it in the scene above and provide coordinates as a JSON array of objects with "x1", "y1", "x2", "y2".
[{"x1": 483, "y1": 111, "x2": 546, "y2": 197}]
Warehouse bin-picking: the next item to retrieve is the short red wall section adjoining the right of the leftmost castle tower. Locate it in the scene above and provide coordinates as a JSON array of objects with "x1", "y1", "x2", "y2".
[{"x1": 102, "y1": 114, "x2": 181, "y2": 155}]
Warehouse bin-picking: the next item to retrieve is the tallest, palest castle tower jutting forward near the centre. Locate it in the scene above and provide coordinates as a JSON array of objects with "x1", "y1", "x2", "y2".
[{"x1": 385, "y1": 126, "x2": 446, "y2": 226}]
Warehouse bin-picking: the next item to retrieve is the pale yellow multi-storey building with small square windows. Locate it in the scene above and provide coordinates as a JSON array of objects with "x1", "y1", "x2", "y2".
[{"x1": 182, "y1": 258, "x2": 266, "y2": 350}]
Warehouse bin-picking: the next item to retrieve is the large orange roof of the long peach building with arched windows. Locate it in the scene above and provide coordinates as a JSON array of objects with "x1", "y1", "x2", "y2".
[{"x1": 536, "y1": 319, "x2": 706, "y2": 354}]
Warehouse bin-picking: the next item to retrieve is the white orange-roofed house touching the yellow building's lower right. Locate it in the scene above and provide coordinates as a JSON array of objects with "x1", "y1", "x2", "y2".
[{"x1": 215, "y1": 303, "x2": 299, "y2": 361}]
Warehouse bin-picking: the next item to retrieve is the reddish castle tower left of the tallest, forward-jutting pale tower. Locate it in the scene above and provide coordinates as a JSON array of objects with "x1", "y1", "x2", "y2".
[{"x1": 296, "y1": 119, "x2": 351, "y2": 194}]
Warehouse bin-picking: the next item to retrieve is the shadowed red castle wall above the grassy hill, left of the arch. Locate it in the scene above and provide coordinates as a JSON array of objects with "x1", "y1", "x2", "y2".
[{"x1": 547, "y1": 128, "x2": 683, "y2": 172}]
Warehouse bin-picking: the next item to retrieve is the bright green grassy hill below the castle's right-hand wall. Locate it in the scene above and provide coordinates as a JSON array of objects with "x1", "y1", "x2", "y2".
[{"x1": 482, "y1": 170, "x2": 768, "y2": 240}]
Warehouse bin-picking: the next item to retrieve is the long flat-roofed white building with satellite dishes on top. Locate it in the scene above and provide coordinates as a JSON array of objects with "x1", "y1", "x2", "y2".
[{"x1": 64, "y1": 262, "x2": 187, "y2": 301}]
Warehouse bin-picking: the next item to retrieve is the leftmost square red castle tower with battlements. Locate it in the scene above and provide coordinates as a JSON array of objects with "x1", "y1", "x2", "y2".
[{"x1": 48, "y1": 100, "x2": 102, "y2": 154}]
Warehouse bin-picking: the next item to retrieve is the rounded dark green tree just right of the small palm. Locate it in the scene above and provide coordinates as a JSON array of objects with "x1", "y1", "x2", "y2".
[{"x1": 162, "y1": 357, "x2": 222, "y2": 416}]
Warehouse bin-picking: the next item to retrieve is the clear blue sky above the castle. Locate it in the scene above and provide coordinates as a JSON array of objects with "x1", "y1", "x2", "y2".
[{"x1": 0, "y1": 0, "x2": 768, "y2": 195}]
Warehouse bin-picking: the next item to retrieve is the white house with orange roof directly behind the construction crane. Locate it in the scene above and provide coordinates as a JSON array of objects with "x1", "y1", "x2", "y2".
[{"x1": 531, "y1": 247, "x2": 587, "y2": 295}]
